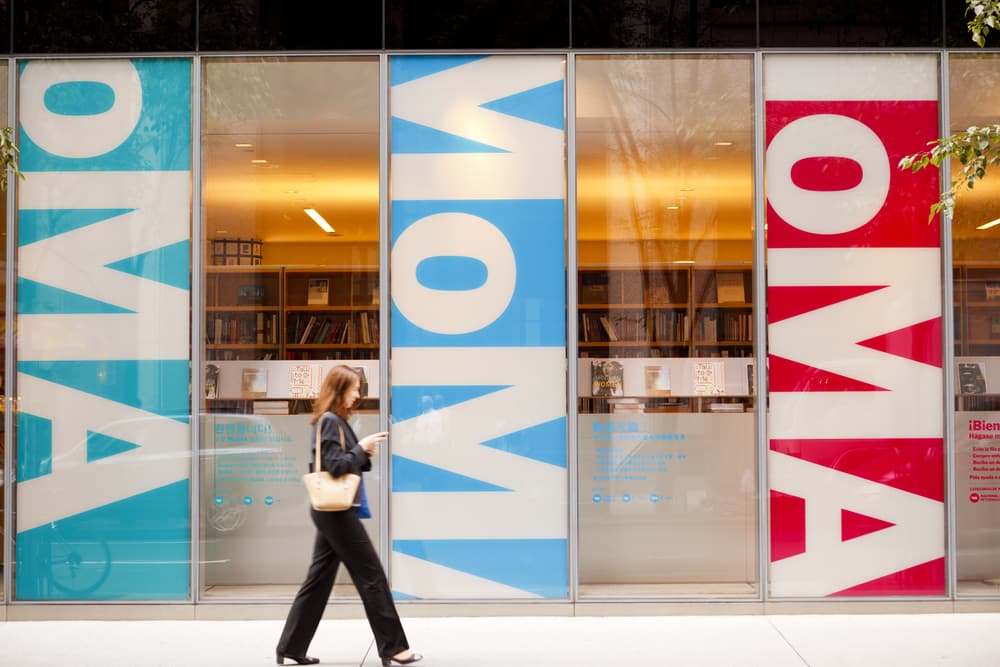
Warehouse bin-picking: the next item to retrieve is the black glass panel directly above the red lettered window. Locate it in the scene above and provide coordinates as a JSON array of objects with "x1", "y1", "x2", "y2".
[{"x1": 759, "y1": 0, "x2": 940, "y2": 48}]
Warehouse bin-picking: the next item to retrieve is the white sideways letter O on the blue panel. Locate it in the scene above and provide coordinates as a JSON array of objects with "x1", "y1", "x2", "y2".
[{"x1": 392, "y1": 212, "x2": 517, "y2": 334}]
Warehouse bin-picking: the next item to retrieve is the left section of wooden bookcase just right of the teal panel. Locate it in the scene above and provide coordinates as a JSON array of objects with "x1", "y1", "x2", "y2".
[{"x1": 205, "y1": 266, "x2": 281, "y2": 360}]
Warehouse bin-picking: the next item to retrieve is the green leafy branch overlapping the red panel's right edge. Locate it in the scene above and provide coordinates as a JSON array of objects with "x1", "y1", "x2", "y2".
[{"x1": 899, "y1": 125, "x2": 1000, "y2": 224}]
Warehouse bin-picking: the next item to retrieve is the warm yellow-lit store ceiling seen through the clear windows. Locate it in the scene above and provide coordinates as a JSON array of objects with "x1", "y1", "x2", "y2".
[{"x1": 202, "y1": 57, "x2": 1000, "y2": 248}]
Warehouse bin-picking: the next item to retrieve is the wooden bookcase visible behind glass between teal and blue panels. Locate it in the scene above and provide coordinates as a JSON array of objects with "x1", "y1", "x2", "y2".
[{"x1": 205, "y1": 266, "x2": 379, "y2": 361}]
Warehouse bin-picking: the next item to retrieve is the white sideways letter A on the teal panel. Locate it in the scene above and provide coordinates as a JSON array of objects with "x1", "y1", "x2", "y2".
[{"x1": 17, "y1": 373, "x2": 191, "y2": 532}]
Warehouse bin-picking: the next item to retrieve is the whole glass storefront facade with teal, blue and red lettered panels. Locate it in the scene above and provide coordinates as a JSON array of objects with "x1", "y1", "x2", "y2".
[{"x1": 0, "y1": 0, "x2": 1000, "y2": 619}]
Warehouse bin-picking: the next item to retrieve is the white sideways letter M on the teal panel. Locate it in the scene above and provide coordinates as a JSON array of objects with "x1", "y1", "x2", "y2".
[{"x1": 18, "y1": 172, "x2": 190, "y2": 360}]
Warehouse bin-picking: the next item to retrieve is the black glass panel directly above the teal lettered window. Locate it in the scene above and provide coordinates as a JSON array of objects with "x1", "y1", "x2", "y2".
[{"x1": 13, "y1": 0, "x2": 195, "y2": 53}]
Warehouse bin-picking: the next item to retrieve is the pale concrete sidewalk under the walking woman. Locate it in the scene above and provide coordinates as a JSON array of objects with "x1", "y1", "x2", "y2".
[{"x1": 0, "y1": 613, "x2": 1000, "y2": 667}]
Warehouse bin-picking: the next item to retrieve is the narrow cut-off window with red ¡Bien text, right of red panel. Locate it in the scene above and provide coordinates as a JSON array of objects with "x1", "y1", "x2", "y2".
[{"x1": 949, "y1": 55, "x2": 1000, "y2": 596}]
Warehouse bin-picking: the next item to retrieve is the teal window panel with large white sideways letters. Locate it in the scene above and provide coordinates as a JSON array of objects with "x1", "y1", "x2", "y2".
[{"x1": 14, "y1": 59, "x2": 192, "y2": 600}]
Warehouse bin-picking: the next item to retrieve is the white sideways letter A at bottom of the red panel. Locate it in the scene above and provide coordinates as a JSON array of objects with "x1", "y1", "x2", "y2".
[{"x1": 768, "y1": 452, "x2": 944, "y2": 596}]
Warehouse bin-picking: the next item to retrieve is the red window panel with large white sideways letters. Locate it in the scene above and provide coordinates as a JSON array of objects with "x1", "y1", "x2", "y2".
[{"x1": 763, "y1": 54, "x2": 945, "y2": 597}]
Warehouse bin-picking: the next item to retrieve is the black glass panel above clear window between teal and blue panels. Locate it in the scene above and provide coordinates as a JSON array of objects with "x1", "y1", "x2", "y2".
[{"x1": 198, "y1": 0, "x2": 382, "y2": 51}]
